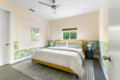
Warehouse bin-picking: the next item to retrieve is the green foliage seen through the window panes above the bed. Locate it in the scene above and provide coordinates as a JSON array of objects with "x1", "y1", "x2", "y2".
[{"x1": 63, "y1": 30, "x2": 77, "y2": 40}]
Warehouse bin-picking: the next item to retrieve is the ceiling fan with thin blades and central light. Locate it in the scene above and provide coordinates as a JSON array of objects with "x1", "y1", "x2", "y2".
[{"x1": 39, "y1": 0, "x2": 68, "y2": 14}]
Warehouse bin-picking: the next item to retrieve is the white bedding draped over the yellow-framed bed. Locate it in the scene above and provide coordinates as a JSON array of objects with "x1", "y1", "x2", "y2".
[{"x1": 31, "y1": 47, "x2": 85, "y2": 78}]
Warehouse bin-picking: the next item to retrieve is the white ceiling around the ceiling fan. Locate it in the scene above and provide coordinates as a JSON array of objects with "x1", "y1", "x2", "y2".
[{"x1": 8, "y1": 0, "x2": 100, "y2": 20}]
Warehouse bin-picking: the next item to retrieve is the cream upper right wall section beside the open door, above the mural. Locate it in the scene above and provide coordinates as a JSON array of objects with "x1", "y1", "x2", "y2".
[{"x1": 99, "y1": 0, "x2": 108, "y2": 42}]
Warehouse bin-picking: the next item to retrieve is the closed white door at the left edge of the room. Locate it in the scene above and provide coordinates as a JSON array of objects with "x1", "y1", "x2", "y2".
[{"x1": 0, "y1": 8, "x2": 10, "y2": 66}]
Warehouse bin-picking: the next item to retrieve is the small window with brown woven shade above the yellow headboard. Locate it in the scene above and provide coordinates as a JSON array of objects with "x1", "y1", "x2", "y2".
[{"x1": 63, "y1": 28, "x2": 77, "y2": 40}]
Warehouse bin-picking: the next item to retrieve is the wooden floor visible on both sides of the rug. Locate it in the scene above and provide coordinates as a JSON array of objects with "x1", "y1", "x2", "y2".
[{"x1": 0, "y1": 59, "x2": 105, "y2": 80}]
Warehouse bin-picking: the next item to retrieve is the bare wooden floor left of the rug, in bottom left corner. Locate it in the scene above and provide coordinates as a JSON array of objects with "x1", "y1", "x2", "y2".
[{"x1": 0, "y1": 65, "x2": 33, "y2": 80}]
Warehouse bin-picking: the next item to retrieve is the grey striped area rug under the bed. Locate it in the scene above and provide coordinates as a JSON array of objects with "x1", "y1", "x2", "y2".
[{"x1": 12, "y1": 60, "x2": 95, "y2": 80}]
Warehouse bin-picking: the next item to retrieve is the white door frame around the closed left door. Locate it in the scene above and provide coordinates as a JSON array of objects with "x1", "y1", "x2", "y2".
[{"x1": 0, "y1": 6, "x2": 14, "y2": 64}]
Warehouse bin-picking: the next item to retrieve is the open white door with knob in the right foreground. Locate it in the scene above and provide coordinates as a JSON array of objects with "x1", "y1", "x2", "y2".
[{"x1": 108, "y1": 0, "x2": 120, "y2": 80}]
